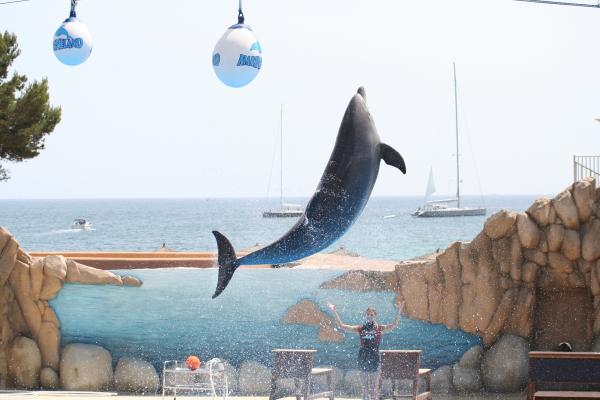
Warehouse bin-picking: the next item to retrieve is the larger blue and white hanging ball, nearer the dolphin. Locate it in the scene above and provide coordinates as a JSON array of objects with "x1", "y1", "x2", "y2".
[{"x1": 212, "y1": 24, "x2": 262, "y2": 88}]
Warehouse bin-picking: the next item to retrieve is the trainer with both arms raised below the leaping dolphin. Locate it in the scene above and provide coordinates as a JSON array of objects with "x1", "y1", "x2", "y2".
[{"x1": 327, "y1": 302, "x2": 404, "y2": 400}]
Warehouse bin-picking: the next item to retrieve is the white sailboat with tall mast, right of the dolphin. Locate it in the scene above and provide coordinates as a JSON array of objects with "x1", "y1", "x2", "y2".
[{"x1": 412, "y1": 63, "x2": 487, "y2": 217}]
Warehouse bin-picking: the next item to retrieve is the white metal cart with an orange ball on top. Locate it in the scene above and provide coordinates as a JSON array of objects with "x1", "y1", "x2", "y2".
[{"x1": 162, "y1": 358, "x2": 229, "y2": 400}]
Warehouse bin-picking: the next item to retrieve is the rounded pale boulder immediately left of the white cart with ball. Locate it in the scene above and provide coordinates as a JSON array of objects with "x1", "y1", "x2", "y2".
[{"x1": 114, "y1": 357, "x2": 159, "y2": 394}]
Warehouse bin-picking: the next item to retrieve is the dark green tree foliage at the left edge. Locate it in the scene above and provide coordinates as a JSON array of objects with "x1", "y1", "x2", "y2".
[{"x1": 0, "y1": 32, "x2": 61, "y2": 181}]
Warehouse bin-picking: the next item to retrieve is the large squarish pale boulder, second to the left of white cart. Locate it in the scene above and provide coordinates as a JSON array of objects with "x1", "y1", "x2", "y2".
[{"x1": 60, "y1": 343, "x2": 113, "y2": 391}]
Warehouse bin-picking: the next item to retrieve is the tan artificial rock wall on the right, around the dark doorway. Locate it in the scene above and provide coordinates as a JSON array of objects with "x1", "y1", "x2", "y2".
[{"x1": 396, "y1": 179, "x2": 600, "y2": 350}]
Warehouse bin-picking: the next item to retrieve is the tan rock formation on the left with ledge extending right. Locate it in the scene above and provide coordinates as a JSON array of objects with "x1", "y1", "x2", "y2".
[{"x1": 0, "y1": 227, "x2": 141, "y2": 389}]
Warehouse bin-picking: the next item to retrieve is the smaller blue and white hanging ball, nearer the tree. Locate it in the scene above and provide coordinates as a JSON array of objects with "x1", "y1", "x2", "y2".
[{"x1": 53, "y1": 17, "x2": 93, "y2": 65}]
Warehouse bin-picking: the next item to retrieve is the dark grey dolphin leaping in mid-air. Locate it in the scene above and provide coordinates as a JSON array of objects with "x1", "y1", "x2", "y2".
[{"x1": 212, "y1": 87, "x2": 406, "y2": 299}]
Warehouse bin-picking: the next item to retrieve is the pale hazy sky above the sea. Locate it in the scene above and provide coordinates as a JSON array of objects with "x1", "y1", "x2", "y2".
[{"x1": 0, "y1": 0, "x2": 600, "y2": 199}]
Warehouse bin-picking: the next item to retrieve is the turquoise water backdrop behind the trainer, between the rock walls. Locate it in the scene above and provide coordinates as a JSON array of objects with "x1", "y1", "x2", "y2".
[{"x1": 51, "y1": 269, "x2": 480, "y2": 369}]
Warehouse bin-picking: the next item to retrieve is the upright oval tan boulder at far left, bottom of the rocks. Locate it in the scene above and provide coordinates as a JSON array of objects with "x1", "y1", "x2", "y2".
[{"x1": 8, "y1": 336, "x2": 42, "y2": 389}]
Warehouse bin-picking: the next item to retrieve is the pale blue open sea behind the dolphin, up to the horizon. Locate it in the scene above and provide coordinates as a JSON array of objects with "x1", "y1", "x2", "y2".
[{"x1": 0, "y1": 195, "x2": 541, "y2": 260}]
